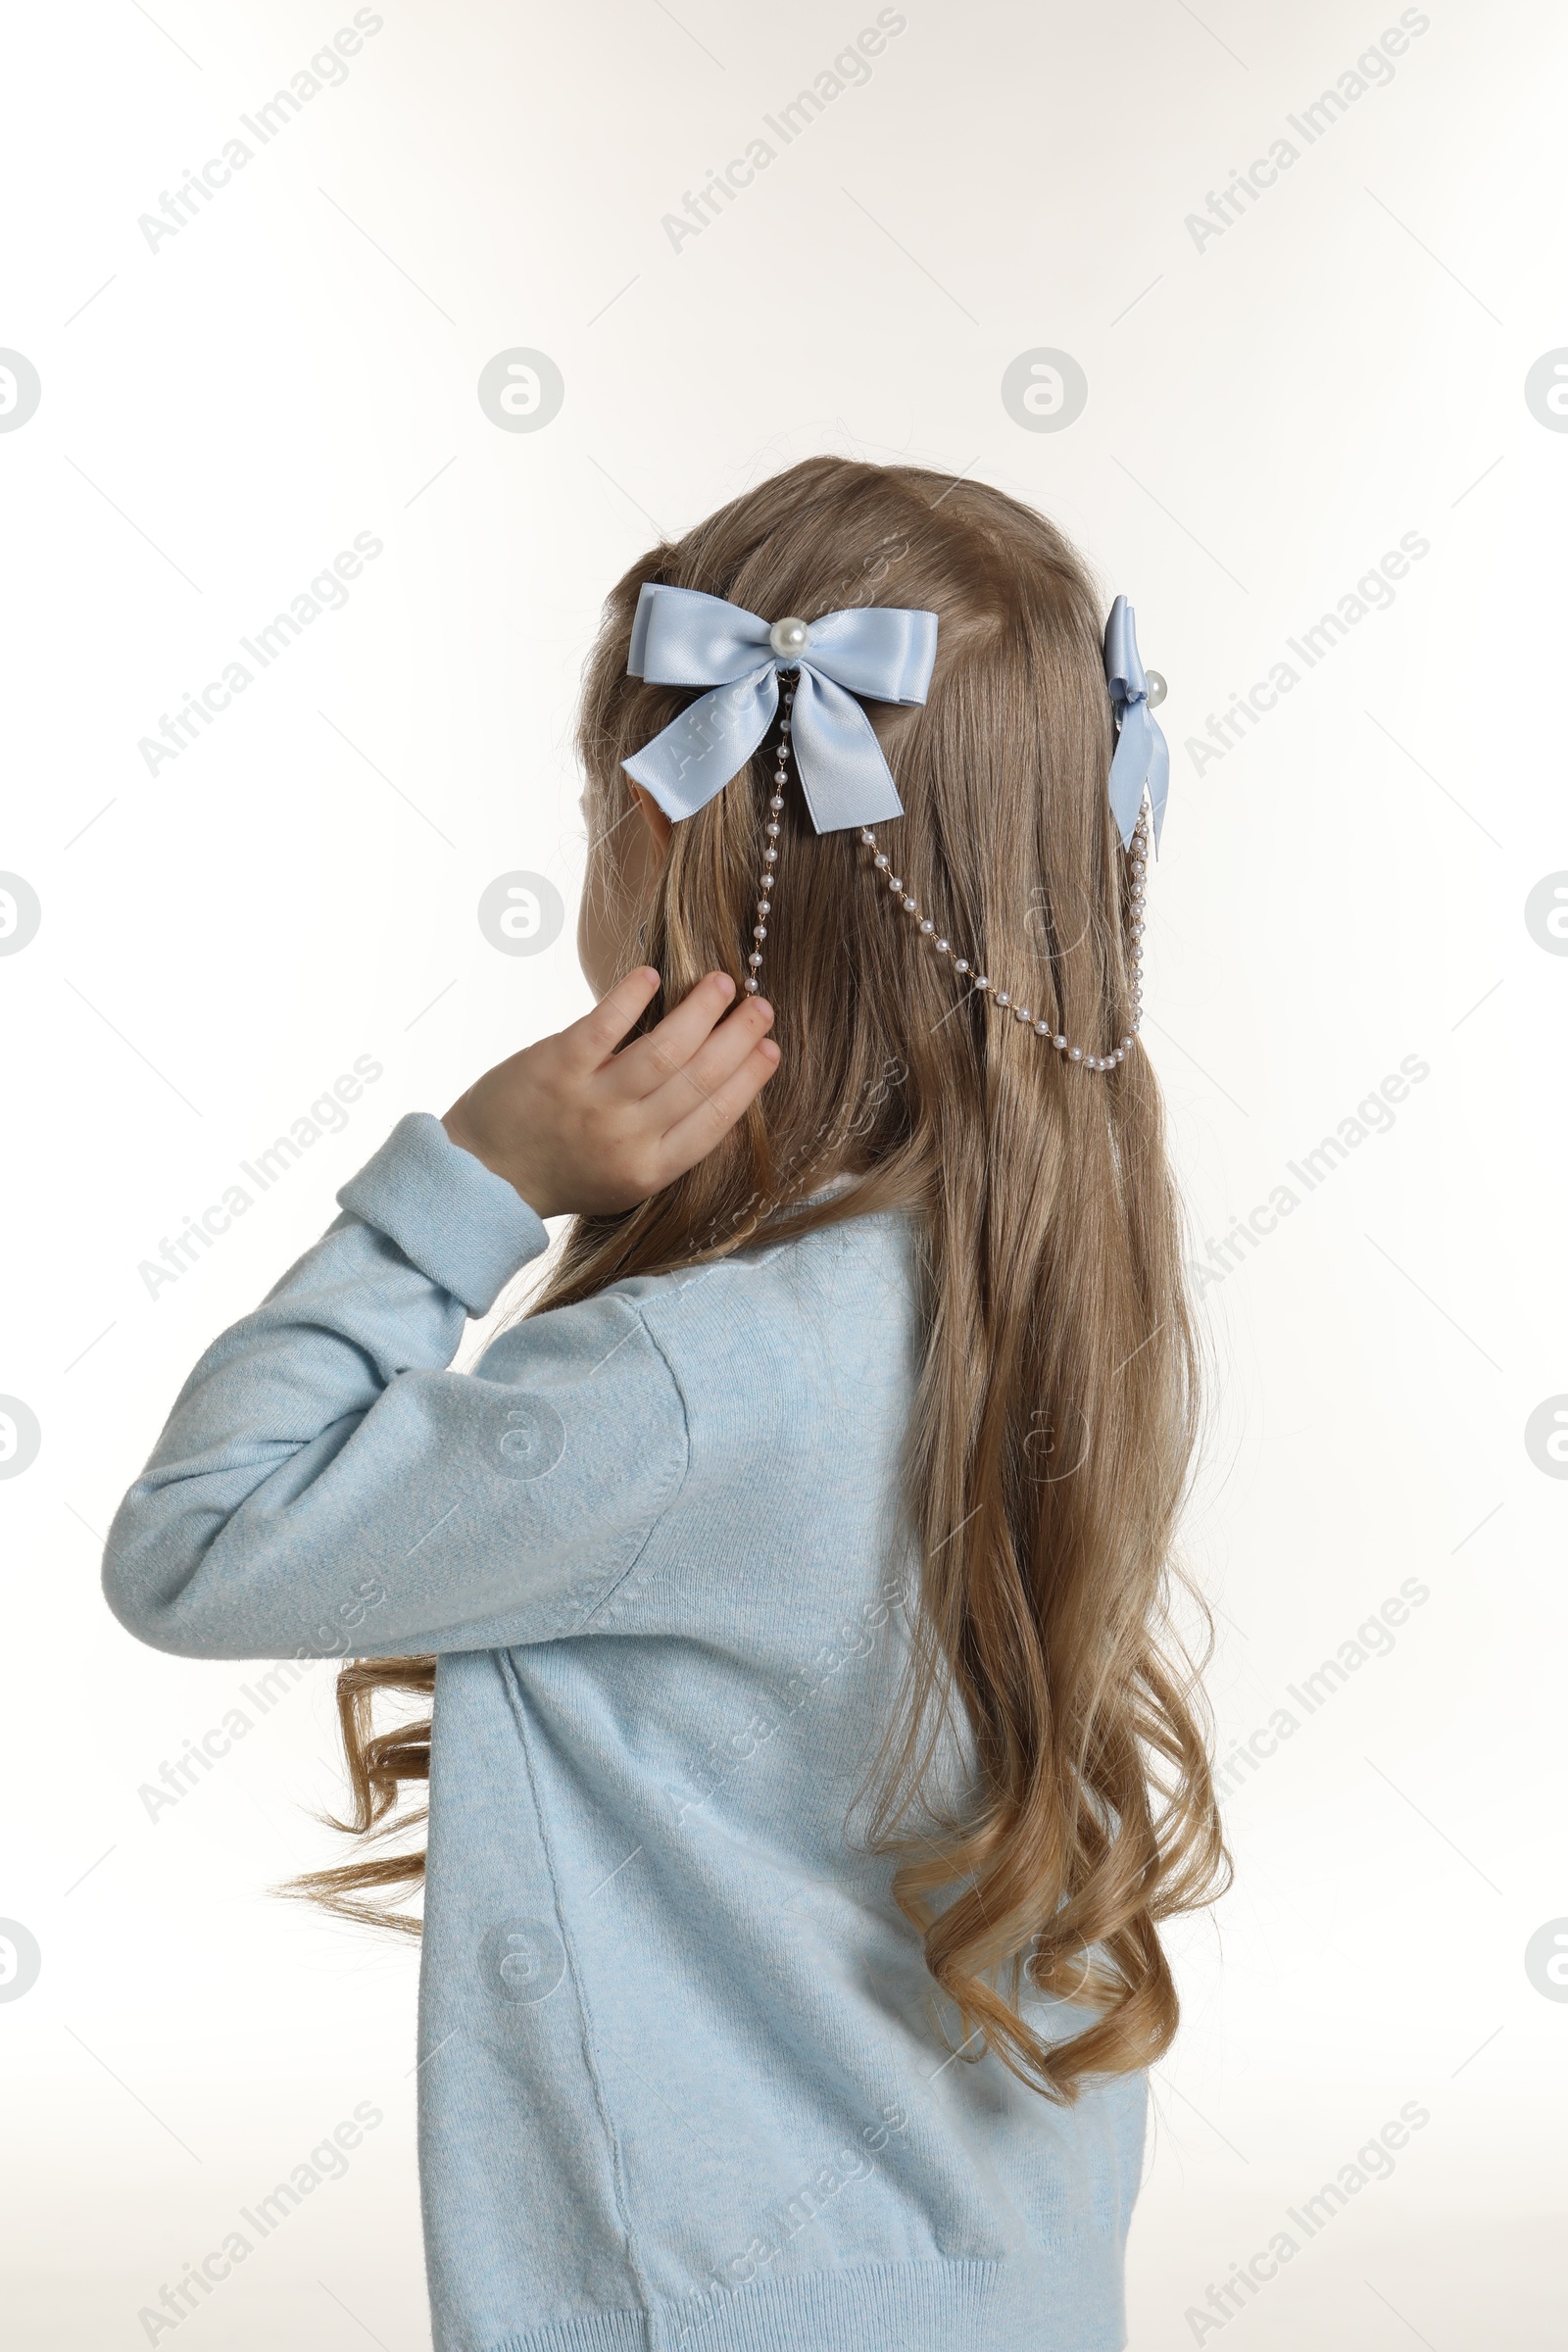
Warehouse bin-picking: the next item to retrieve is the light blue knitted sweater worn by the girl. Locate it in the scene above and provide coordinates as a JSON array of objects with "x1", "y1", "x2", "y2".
[{"x1": 104, "y1": 1112, "x2": 1145, "y2": 2352}]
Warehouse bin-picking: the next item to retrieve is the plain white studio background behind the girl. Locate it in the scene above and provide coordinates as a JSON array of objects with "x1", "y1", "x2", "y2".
[{"x1": 0, "y1": 0, "x2": 1568, "y2": 2352}]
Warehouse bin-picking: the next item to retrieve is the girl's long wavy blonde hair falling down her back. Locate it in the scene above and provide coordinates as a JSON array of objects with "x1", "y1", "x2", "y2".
[{"x1": 296, "y1": 457, "x2": 1230, "y2": 2100}]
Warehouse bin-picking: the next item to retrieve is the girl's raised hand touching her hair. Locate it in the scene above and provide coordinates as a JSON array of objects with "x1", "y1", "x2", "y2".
[{"x1": 442, "y1": 964, "x2": 778, "y2": 1216}]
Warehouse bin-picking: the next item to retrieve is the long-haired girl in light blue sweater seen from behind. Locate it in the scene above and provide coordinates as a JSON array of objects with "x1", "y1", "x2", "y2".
[{"x1": 104, "y1": 459, "x2": 1225, "y2": 2352}]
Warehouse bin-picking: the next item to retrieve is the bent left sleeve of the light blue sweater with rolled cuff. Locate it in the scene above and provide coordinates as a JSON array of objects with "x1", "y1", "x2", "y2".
[{"x1": 104, "y1": 1112, "x2": 686, "y2": 1658}]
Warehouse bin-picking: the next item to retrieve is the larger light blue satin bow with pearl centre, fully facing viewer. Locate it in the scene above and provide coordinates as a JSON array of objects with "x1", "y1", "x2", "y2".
[{"x1": 620, "y1": 581, "x2": 940, "y2": 833}]
